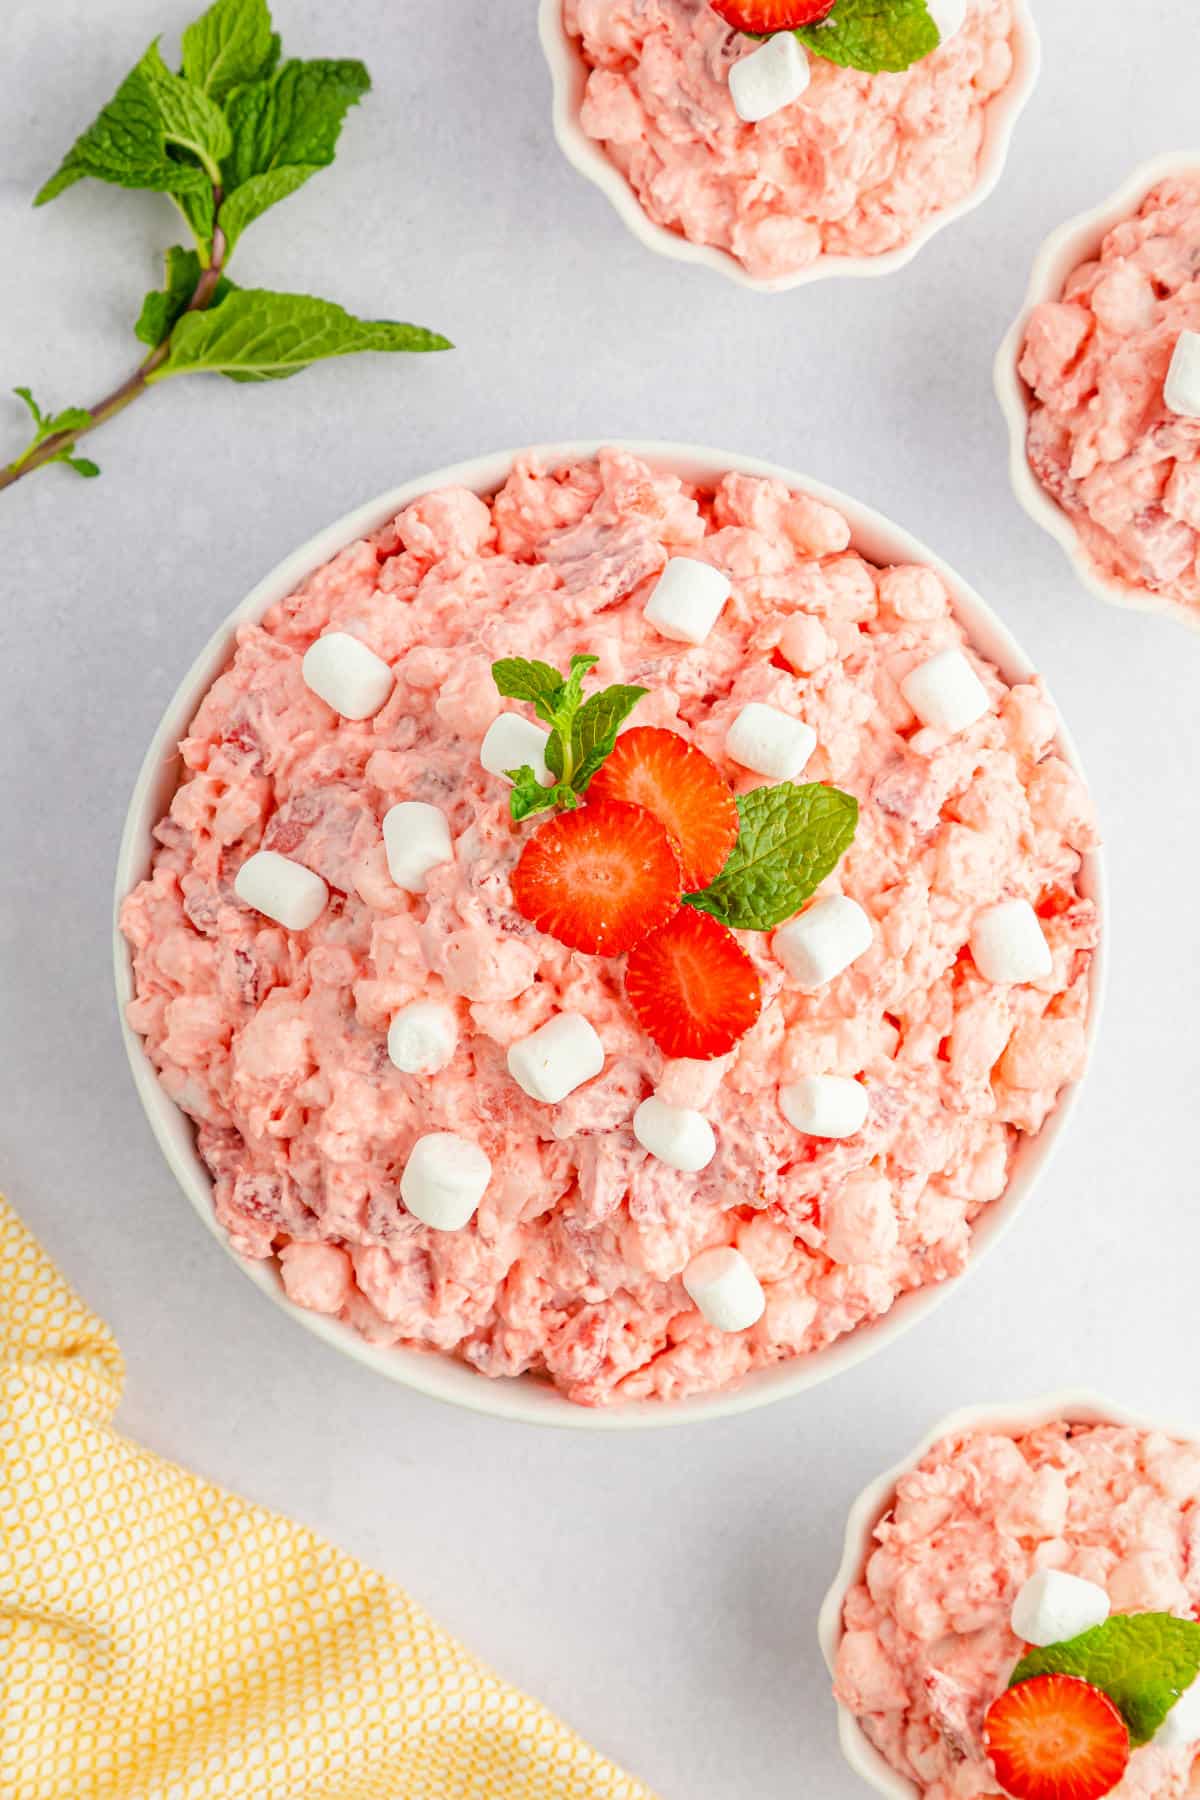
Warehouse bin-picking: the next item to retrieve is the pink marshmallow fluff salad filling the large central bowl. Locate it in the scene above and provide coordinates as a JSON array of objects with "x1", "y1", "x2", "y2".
[{"x1": 122, "y1": 450, "x2": 1097, "y2": 1406}]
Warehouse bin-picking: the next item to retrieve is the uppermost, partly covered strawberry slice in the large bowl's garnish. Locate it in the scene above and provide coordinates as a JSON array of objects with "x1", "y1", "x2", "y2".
[{"x1": 588, "y1": 725, "x2": 739, "y2": 895}]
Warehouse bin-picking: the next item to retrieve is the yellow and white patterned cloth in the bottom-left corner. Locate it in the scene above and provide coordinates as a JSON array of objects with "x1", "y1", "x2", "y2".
[{"x1": 0, "y1": 1201, "x2": 653, "y2": 1800}]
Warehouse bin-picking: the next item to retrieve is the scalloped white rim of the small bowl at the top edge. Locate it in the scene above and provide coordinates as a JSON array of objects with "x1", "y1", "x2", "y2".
[{"x1": 538, "y1": 0, "x2": 1042, "y2": 293}]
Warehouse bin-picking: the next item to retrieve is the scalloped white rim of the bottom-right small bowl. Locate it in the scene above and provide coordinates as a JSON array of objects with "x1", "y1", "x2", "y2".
[{"x1": 817, "y1": 1388, "x2": 1200, "y2": 1800}]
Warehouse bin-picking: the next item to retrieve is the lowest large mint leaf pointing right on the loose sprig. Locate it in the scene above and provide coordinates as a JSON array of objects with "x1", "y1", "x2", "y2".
[{"x1": 149, "y1": 288, "x2": 450, "y2": 382}]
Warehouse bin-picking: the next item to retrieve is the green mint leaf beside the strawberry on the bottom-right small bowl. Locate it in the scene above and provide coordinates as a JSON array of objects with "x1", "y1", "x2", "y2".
[{"x1": 1009, "y1": 1613, "x2": 1200, "y2": 1744}]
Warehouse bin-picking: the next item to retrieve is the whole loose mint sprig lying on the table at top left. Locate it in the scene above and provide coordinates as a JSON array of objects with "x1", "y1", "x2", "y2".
[{"x1": 0, "y1": 0, "x2": 450, "y2": 488}]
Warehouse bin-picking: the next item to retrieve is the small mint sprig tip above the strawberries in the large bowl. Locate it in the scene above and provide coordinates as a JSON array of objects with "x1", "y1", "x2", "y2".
[{"x1": 491, "y1": 657, "x2": 648, "y2": 824}]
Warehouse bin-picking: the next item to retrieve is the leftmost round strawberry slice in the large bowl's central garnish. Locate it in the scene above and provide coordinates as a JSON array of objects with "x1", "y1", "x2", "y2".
[{"x1": 513, "y1": 801, "x2": 682, "y2": 956}]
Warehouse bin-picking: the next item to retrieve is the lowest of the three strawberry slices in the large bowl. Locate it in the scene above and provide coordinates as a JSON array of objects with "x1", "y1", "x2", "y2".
[{"x1": 624, "y1": 905, "x2": 763, "y2": 1062}]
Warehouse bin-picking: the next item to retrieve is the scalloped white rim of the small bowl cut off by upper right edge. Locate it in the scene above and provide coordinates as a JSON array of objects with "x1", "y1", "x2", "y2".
[{"x1": 993, "y1": 149, "x2": 1200, "y2": 630}]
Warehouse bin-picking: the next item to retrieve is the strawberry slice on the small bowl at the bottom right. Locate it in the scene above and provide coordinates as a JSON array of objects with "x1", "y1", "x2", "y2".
[{"x1": 984, "y1": 1676, "x2": 1130, "y2": 1800}]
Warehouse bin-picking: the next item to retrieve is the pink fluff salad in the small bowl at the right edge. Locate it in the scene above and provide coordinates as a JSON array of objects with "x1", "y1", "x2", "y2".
[{"x1": 1020, "y1": 171, "x2": 1200, "y2": 617}]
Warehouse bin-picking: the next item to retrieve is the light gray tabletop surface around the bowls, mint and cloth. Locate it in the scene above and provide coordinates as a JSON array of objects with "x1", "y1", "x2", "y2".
[{"x1": 0, "y1": 0, "x2": 1200, "y2": 1800}]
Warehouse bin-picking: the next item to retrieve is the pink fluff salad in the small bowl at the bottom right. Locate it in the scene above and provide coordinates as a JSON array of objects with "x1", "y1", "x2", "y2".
[{"x1": 835, "y1": 1420, "x2": 1200, "y2": 1800}]
